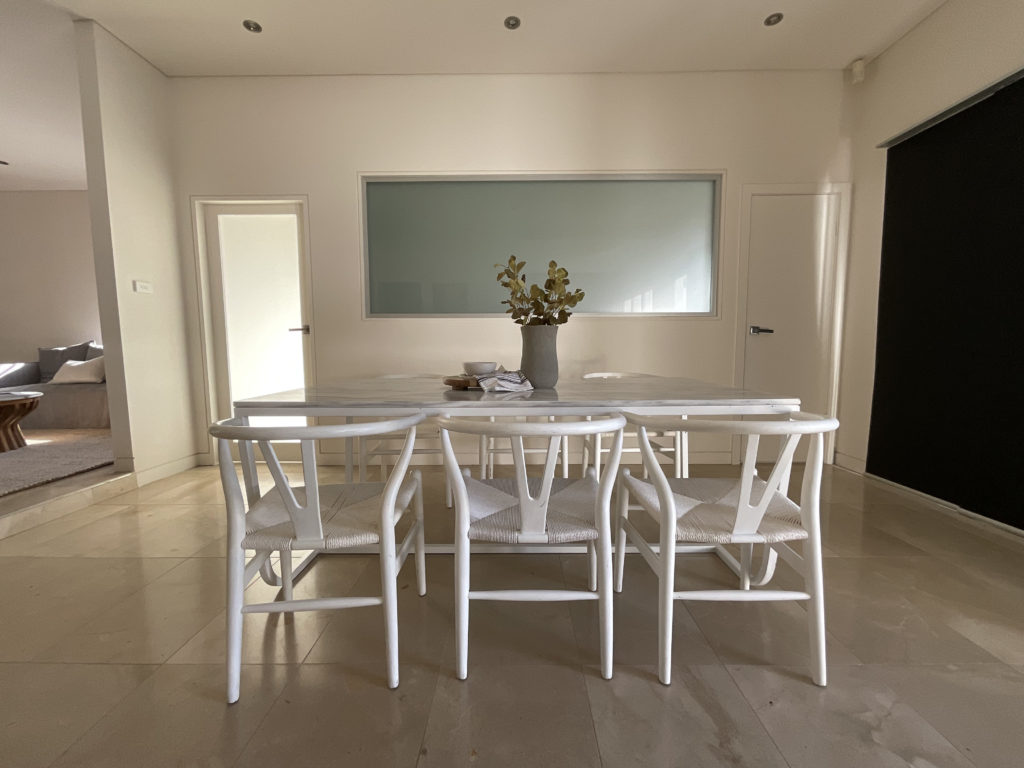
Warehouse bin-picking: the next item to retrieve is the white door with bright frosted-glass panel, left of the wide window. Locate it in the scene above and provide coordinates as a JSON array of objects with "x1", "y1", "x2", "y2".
[{"x1": 205, "y1": 203, "x2": 312, "y2": 425}]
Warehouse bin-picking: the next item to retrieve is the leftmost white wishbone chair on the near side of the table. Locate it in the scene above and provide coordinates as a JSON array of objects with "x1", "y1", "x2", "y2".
[{"x1": 210, "y1": 414, "x2": 427, "y2": 703}]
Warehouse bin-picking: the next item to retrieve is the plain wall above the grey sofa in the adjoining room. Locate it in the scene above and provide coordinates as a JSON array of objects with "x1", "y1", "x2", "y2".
[{"x1": 0, "y1": 190, "x2": 102, "y2": 362}]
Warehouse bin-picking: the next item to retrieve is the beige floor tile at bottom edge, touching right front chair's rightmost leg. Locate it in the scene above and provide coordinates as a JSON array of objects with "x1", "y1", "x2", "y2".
[{"x1": 728, "y1": 667, "x2": 971, "y2": 768}]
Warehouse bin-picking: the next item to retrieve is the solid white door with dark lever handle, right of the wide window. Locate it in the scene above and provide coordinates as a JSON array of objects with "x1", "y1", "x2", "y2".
[{"x1": 743, "y1": 191, "x2": 843, "y2": 461}]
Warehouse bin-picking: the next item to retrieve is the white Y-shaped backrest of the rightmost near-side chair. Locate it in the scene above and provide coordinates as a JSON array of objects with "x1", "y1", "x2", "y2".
[{"x1": 624, "y1": 412, "x2": 839, "y2": 542}]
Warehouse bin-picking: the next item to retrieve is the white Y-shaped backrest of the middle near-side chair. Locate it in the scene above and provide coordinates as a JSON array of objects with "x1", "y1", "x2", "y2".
[{"x1": 437, "y1": 416, "x2": 626, "y2": 544}]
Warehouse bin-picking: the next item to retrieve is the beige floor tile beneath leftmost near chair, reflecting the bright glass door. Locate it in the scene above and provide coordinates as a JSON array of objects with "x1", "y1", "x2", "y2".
[{"x1": 168, "y1": 555, "x2": 372, "y2": 664}]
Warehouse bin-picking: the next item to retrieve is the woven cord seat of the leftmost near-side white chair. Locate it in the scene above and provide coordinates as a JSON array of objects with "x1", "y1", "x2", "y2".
[{"x1": 242, "y1": 476, "x2": 416, "y2": 550}]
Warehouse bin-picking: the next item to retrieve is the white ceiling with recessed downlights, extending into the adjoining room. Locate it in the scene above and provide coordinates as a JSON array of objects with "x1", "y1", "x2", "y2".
[{"x1": 0, "y1": 0, "x2": 944, "y2": 190}]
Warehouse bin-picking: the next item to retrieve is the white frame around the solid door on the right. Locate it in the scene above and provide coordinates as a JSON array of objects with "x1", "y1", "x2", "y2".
[{"x1": 732, "y1": 182, "x2": 853, "y2": 464}]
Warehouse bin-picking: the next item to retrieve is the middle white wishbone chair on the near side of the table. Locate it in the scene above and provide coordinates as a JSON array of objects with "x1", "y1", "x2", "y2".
[{"x1": 438, "y1": 416, "x2": 626, "y2": 680}]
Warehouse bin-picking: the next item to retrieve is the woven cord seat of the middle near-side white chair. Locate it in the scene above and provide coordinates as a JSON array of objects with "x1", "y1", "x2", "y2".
[{"x1": 466, "y1": 476, "x2": 598, "y2": 544}]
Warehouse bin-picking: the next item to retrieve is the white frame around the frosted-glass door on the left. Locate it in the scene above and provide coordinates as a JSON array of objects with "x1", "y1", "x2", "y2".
[{"x1": 189, "y1": 195, "x2": 316, "y2": 464}]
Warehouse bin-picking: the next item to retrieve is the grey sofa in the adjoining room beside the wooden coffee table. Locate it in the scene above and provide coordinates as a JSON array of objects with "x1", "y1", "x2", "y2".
[{"x1": 0, "y1": 342, "x2": 111, "y2": 429}]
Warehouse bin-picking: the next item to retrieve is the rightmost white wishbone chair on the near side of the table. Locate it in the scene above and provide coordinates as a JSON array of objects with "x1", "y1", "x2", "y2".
[{"x1": 615, "y1": 413, "x2": 839, "y2": 685}]
